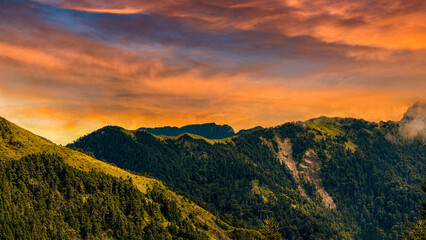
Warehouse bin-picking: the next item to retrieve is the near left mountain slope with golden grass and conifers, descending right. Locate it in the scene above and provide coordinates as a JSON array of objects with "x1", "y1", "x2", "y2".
[{"x1": 0, "y1": 118, "x2": 264, "y2": 239}]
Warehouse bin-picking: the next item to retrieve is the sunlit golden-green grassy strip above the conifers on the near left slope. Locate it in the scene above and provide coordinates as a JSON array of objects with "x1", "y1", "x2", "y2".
[{"x1": 0, "y1": 117, "x2": 259, "y2": 239}]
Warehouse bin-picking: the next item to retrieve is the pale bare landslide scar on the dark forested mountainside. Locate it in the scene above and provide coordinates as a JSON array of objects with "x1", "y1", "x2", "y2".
[{"x1": 261, "y1": 137, "x2": 336, "y2": 209}]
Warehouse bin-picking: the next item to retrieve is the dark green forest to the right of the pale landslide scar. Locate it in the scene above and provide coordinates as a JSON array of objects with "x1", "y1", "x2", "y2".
[{"x1": 315, "y1": 119, "x2": 426, "y2": 239}]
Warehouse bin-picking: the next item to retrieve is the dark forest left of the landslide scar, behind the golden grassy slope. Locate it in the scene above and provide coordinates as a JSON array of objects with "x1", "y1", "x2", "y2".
[{"x1": 68, "y1": 124, "x2": 344, "y2": 239}]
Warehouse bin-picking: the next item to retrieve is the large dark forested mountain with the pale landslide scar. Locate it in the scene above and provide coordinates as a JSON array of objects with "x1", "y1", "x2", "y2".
[{"x1": 69, "y1": 105, "x2": 426, "y2": 239}]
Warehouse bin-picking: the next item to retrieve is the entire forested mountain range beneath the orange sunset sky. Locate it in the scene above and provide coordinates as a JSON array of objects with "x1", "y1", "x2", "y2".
[{"x1": 0, "y1": 103, "x2": 426, "y2": 239}]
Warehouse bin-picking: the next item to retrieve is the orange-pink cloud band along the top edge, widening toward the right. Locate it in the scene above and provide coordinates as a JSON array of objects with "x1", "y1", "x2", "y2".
[{"x1": 39, "y1": 0, "x2": 426, "y2": 49}]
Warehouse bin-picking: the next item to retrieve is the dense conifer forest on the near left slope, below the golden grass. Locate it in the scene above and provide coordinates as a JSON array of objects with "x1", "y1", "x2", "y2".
[{"x1": 0, "y1": 154, "x2": 208, "y2": 239}]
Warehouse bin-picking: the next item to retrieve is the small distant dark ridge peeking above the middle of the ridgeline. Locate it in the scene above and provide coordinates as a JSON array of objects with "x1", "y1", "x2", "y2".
[{"x1": 138, "y1": 123, "x2": 262, "y2": 139}]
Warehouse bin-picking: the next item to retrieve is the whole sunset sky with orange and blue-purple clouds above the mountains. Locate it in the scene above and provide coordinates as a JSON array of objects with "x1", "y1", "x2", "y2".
[{"x1": 0, "y1": 0, "x2": 426, "y2": 144}]
